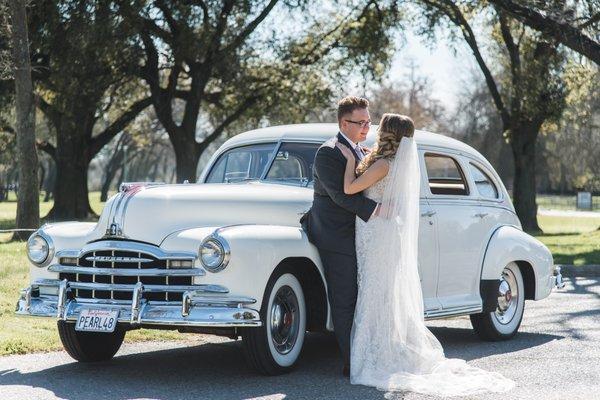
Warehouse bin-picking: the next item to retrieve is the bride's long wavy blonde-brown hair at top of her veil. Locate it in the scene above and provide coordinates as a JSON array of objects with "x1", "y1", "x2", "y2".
[{"x1": 356, "y1": 114, "x2": 415, "y2": 175}]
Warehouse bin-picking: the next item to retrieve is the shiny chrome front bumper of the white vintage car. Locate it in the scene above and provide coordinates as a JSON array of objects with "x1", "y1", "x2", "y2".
[{"x1": 16, "y1": 279, "x2": 262, "y2": 328}]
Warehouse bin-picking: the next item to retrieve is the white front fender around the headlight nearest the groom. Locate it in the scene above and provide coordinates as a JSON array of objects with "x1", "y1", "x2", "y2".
[{"x1": 161, "y1": 225, "x2": 325, "y2": 309}]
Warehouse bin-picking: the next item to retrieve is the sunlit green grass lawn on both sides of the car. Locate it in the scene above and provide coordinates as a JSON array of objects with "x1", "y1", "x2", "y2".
[{"x1": 0, "y1": 192, "x2": 600, "y2": 355}]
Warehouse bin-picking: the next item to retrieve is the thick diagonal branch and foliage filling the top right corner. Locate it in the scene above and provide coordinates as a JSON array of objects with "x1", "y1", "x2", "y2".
[{"x1": 489, "y1": 0, "x2": 600, "y2": 65}]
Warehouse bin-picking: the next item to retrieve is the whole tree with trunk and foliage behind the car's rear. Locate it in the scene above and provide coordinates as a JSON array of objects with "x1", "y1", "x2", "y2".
[{"x1": 421, "y1": 0, "x2": 566, "y2": 231}]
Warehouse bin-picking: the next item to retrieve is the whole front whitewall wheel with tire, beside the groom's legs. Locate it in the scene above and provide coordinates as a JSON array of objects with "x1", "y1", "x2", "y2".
[{"x1": 242, "y1": 273, "x2": 306, "y2": 375}]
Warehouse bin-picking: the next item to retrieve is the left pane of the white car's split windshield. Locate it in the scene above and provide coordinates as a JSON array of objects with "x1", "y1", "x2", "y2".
[{"x1": 206, "y1": 143, "x2": 276, "y2": 183}]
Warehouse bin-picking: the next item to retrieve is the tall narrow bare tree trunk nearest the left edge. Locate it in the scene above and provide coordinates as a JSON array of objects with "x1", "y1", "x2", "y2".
[{"x1": 10, "y1": 0, "x2": 40, "y2": 240}]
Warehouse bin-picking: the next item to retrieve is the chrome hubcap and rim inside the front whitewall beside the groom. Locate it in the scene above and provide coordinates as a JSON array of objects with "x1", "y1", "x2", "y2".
[{"x1": 271, "y1": 286, "x2": 300, "y2": 354}]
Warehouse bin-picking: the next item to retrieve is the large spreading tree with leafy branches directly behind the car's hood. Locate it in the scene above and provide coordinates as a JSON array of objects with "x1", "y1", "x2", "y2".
[{"x1": 121, "y1": 0, "x2": 398, "y2": 182}]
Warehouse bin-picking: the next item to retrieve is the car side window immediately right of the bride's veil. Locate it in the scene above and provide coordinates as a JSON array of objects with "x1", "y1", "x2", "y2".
[{"x1": 425, "y1": 153, "x2": 469, "y2": 196}]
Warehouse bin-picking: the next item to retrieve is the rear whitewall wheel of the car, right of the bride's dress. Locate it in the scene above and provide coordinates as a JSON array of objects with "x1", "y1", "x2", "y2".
[{"x1": 471, "y1": 262, "x2": 525, "y2": 341}]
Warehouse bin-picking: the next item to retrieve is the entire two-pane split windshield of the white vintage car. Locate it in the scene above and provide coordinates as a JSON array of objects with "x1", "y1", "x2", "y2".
[{"x1": 205, "y1": 142, "x2": 320, "y2": 186}]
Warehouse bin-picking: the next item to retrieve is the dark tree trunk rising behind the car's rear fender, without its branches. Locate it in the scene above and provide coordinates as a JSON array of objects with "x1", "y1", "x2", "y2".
[{"x1": 511, "y1": 127, "x2": 541, "y2": 233}]
